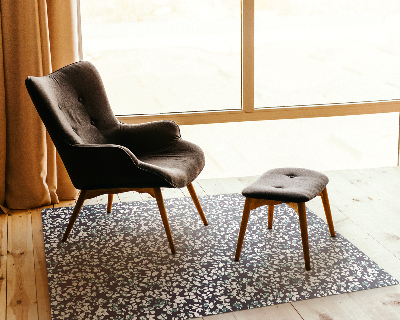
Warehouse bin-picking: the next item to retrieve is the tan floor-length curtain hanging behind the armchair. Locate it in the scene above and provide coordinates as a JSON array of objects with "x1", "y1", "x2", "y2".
[{"x1": 0, "y1": 0, "x2": 78, "y2": 211}]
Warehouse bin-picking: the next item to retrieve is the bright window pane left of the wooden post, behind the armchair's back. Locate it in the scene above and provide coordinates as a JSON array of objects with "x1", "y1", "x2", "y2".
[{"x1": 81, "y1": 0, "x2": 241, "y2": 115}]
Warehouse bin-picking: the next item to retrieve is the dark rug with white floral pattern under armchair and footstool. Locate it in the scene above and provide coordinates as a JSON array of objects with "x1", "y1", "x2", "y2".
[{"x1": 42, "y1": 194, "x2": 398, "y2": 320}]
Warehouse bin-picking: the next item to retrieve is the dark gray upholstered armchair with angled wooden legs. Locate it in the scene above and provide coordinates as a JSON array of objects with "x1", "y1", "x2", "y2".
[{"x1": 25, "y1": 61, "x2": 207, "y2": 253}]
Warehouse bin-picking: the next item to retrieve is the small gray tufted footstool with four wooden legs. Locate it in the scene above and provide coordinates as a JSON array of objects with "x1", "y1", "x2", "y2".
[{"x1": 235, "y1": 168, "x2": 335, "y2": 270}]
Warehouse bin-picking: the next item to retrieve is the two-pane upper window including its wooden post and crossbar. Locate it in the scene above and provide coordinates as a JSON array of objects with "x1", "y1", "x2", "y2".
[{"x1": 80, "y1": 0, "x2": 400, "y2": 124}]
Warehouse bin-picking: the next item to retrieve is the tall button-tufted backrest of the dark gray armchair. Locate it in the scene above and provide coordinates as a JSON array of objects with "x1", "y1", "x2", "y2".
[{"x1": 25, "y1": 61, "x2": 119, "y2": 149}]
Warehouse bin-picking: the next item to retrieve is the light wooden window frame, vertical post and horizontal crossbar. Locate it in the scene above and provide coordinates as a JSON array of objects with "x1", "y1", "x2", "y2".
[{"x1": 77, "y1": 0, "x2": 400, "y2": 125}]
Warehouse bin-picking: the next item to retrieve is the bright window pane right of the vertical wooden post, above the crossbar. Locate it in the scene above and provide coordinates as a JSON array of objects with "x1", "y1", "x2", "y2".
[{"x1": 254, "y1": 0, "x2": 400, "y2": 108}]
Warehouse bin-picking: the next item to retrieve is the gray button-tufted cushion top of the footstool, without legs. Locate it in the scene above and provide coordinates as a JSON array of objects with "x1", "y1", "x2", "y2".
[{"x1": 242, "y1": 168, "x2": 329, "y2": 203}]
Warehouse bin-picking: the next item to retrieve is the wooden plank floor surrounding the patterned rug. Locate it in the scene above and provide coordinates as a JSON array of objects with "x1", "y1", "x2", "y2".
[{"x1": 0, "y1": 167, "x2": 400, "y2": 320}]
